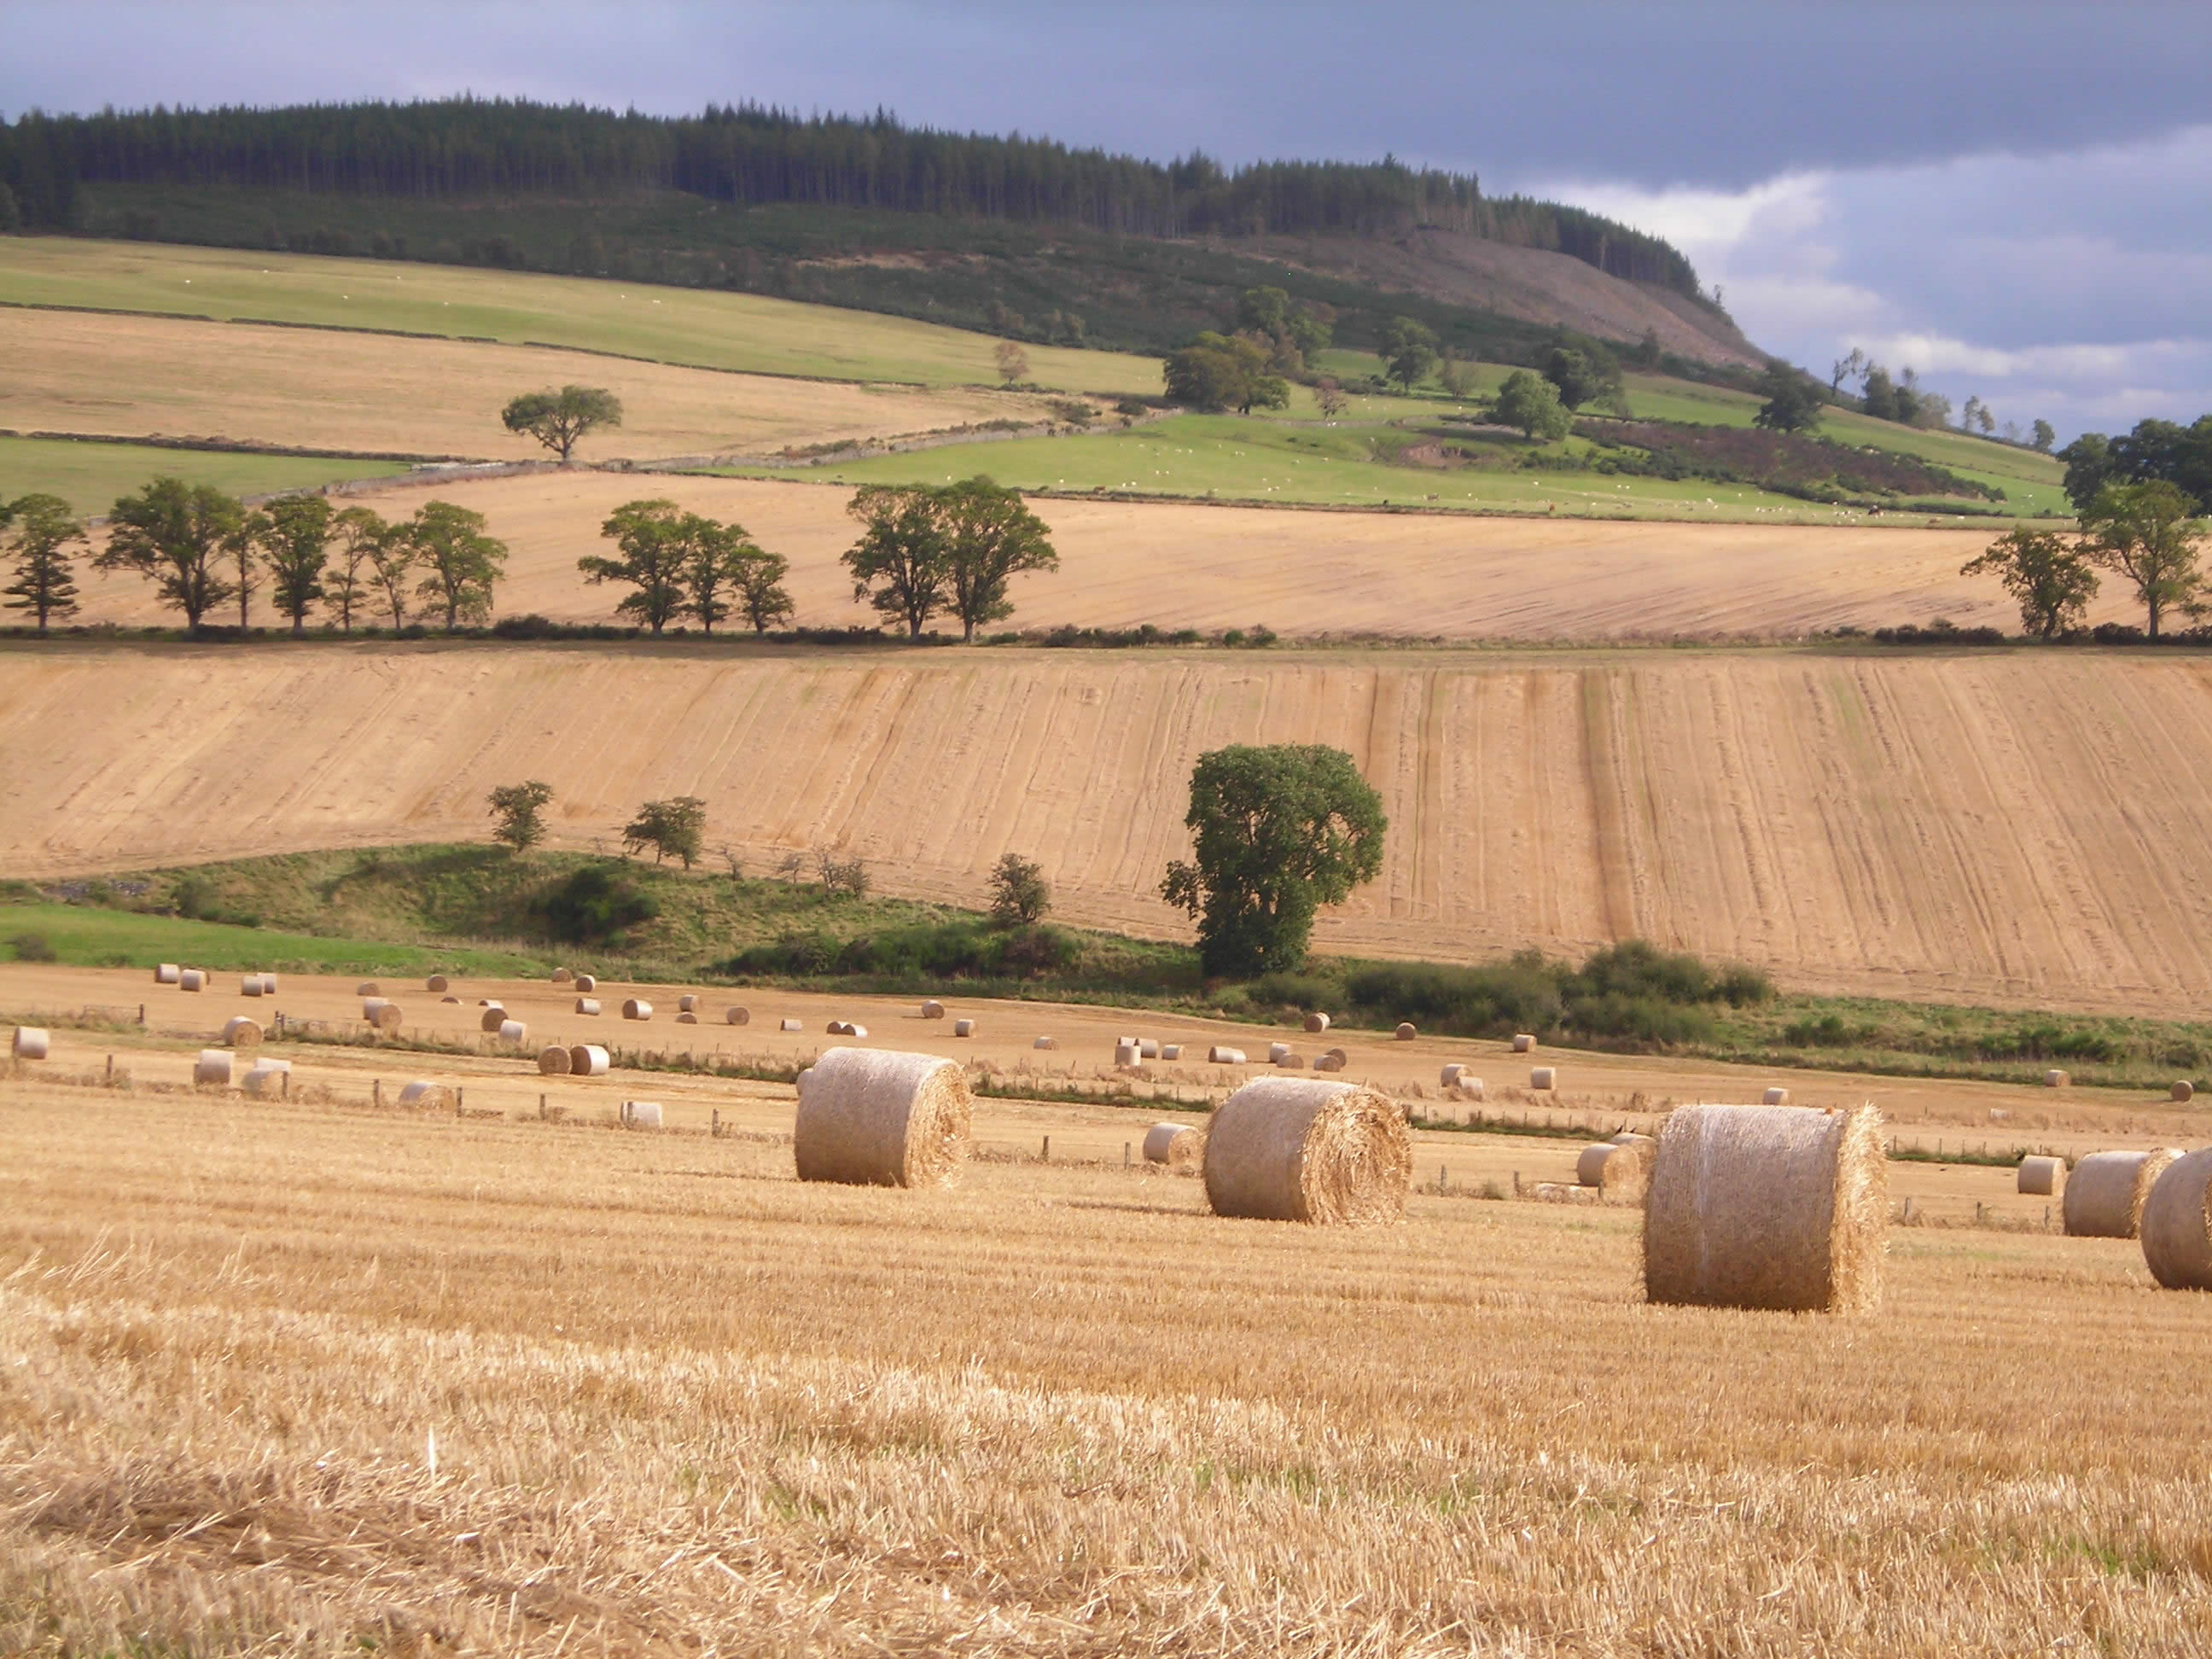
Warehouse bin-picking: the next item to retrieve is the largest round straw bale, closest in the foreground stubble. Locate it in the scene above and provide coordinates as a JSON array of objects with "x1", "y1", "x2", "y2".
[{"x1": 1644, "y1": 1106, "x2": 1889, "y2": 1314}]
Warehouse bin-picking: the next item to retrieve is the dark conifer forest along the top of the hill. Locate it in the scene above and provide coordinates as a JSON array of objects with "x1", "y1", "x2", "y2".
[{"x1": 0, "y1": 97, "x2": 1701, "y2": 296}]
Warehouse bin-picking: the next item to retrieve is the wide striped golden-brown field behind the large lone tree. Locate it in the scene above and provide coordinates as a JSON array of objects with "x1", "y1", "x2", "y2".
[{"x1": 0, "y1": 643, "x2": 2212, "y2": 1013}]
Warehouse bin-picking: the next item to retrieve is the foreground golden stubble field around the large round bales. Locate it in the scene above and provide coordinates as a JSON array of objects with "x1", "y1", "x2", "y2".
[{"x1": 0, "y1": 995, "x2": 2212, "y2": 1655}]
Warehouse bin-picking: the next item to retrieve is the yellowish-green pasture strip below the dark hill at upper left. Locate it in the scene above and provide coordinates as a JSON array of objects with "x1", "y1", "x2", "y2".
[{"x1": 0, "y1": 236, "x2": 1161, "y2": 396}]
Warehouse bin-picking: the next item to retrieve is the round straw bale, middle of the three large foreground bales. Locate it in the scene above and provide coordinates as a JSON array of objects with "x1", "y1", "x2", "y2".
[{"x1": 1206, "y1": 1077, "x2": 1413, "y2": 1223}]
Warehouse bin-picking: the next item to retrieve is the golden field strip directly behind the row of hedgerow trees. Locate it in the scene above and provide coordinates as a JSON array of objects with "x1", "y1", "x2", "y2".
[{"x1": 69, "y1": 473, "x2": 2097, "y2": 639}]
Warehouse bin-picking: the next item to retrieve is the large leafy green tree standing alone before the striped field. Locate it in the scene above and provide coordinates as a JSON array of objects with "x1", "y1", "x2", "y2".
[{"x1": 1159, "y1": 743, "x2": 1389, "y2": 978}]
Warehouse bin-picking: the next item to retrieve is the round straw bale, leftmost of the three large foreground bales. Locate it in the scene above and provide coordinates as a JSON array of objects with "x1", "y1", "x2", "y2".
[{"x1": 792, "y1": 1049, "x2": 973, "y2": 1185}]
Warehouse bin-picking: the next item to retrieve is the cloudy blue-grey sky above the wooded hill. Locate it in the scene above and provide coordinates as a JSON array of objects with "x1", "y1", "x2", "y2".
[{"x1": 0, "y1": 0, "x2": 2212, "y2": 440}]
